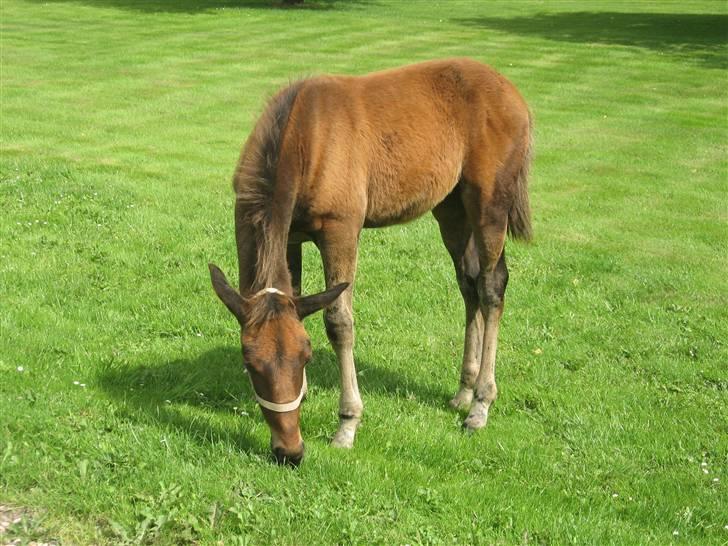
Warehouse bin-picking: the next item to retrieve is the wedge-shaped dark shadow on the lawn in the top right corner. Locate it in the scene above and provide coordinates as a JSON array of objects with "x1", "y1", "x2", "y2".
[{"x1": 455, "y1": 12, "x2": 728, "y2": 68}]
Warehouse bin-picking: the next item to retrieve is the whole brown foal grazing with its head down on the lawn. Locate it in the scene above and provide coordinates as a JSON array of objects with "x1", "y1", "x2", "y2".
[{"x1": 210, "y1": 59, "x2": 532, "y2": 465}]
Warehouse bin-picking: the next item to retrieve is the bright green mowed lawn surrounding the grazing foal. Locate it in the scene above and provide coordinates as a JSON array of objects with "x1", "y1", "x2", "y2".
[{"x1": 0, "y1": 0, "x2": 728, "y2": 545}]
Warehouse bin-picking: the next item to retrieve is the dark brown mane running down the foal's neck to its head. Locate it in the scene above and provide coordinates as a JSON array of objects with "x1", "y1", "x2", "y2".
[{"x1": 233, "y1": 80, "x2": 306, "y2": 287}]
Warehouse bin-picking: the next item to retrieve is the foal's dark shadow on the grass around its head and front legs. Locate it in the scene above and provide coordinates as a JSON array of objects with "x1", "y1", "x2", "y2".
[{"x1": 98, "y1": 345, "x2": 447, "y2": 455}]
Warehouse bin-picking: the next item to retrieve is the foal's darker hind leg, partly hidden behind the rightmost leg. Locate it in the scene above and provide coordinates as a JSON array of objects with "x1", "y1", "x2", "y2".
[{"x1": 432, "y1": 191, "x2": 483, "y2": 409}]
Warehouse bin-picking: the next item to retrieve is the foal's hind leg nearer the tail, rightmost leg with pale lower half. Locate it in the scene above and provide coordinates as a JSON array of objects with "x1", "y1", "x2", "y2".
[{"x1": 463, "y1": 186, "x2": 508, "y2": 431}]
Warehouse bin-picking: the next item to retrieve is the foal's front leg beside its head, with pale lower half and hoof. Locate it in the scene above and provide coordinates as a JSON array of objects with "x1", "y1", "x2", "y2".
[{"x1": 317, "y1": 224, "x2": 364, "y2": 448}]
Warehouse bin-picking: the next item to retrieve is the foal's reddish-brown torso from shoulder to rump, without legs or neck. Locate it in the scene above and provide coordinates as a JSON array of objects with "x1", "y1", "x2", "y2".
[{"x1": 281, "y1": 59, "x2": 529, "y2": 230}]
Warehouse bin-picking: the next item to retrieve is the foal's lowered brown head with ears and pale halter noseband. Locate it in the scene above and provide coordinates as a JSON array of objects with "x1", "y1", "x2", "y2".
[{"x1": 210, "y1": 264, "x2": 348, "y2": 465}]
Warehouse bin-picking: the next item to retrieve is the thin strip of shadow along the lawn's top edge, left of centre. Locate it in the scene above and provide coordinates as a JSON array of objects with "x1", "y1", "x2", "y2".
[{"x1": 22, "y1": 0, "x2": 374, "y2": 14}]
